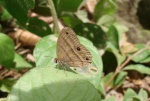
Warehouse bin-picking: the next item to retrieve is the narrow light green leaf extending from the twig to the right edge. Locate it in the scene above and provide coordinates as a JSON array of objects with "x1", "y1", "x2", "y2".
[{"x1": 123, "y1": 64, "x2": 150, "y2": 75}]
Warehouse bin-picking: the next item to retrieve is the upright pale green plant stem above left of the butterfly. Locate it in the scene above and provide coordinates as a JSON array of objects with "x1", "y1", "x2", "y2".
[{"x1": 47, "y1": 0, "x2": 60, "y2": 33}]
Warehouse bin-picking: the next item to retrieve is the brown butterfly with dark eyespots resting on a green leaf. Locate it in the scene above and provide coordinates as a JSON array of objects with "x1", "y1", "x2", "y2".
[{"x1": 55, "y1": 27, "x2": 92, "y2": 67}]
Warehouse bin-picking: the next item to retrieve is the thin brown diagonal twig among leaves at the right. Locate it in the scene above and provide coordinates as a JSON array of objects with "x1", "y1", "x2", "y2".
[{"x1": 105, "y1": 42, "x2": 150, "y2": 89}]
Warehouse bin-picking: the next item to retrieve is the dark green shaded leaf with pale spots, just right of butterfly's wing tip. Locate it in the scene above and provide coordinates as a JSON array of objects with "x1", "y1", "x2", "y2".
[{"x1": 74, "y1": 23, "x2": 106, "y2": 48}]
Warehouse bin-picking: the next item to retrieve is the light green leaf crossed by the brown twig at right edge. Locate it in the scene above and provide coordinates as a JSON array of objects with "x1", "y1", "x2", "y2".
[{"x1": 132, "y1": 44, "x2": 150, "y2": 63}]
